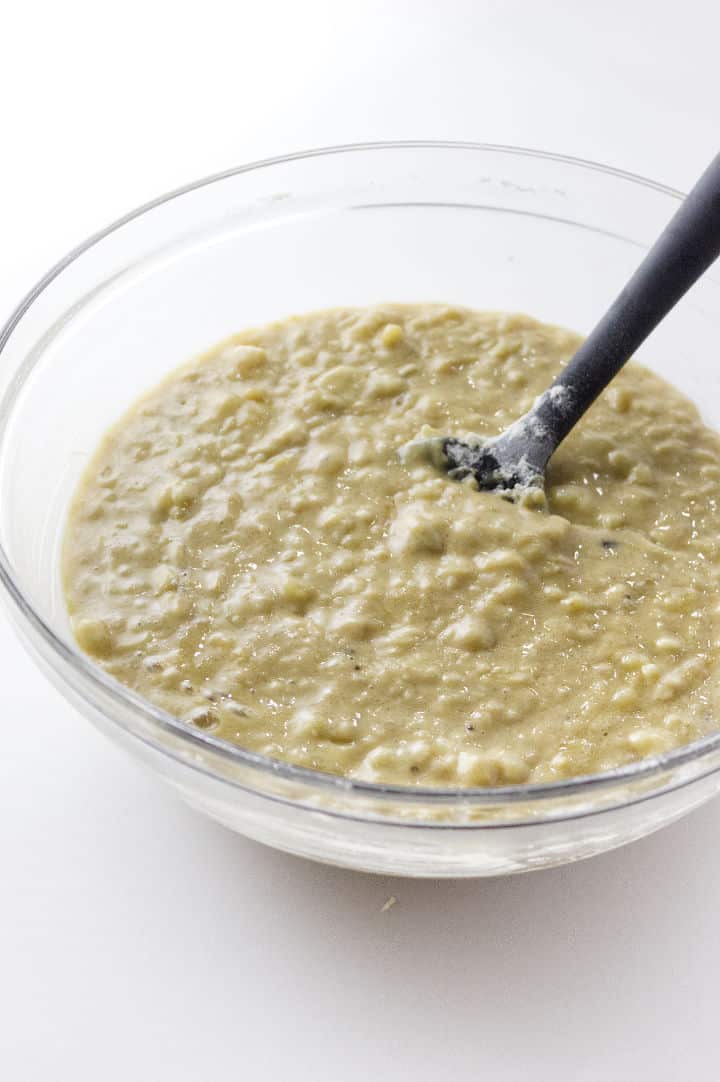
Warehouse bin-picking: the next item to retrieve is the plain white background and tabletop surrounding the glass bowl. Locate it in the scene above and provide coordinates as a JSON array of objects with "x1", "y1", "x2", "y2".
[{"x1": 0, "y1": 0, "x2": 720, "y2": 1082}]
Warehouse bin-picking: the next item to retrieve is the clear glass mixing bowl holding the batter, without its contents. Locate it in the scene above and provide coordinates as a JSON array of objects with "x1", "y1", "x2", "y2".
[{"x1": 0, "y1": 143, "x2": 720, "y2": 876}]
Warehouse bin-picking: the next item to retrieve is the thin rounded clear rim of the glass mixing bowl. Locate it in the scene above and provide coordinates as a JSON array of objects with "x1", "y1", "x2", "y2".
[{"x1": 5, "y1": 140, "x2": 720, "y2": 813}]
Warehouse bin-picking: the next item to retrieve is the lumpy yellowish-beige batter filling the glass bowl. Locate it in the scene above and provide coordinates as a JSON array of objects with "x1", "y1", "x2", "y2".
[{"x1": 64, "y1": 304, "x2": 720, "y2": 786}]
